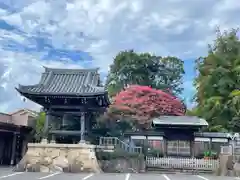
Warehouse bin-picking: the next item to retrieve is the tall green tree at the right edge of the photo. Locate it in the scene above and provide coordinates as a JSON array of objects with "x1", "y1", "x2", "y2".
[{"x1": 195, "y1": 30, "x2": 240, "y2": 131}]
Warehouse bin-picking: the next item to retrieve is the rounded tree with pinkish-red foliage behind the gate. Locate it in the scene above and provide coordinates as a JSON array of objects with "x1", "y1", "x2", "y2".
[{"x1": 106, "y1": 85, "x2": 186, "y2": 127}]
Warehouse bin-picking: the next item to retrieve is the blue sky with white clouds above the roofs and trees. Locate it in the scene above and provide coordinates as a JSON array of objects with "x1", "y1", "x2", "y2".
[{"x1": 0, "y1": 0, "x2": 240, "y2": 112}]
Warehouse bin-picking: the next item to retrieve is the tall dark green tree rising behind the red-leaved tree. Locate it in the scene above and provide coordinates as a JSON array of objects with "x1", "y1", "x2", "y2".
[{"x1": 106, "y1": 50, "x2": 184, "y2": 96}]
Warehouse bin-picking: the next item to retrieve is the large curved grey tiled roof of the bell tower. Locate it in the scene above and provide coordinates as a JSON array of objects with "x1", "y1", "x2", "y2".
[{"x1": 17, "y1": 67, "x2": 105, "y2": 96}]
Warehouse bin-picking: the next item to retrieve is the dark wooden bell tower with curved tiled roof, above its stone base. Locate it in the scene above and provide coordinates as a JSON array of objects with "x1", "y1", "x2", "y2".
[{"x1": 17, "y1": 67, "x2": 110, "y2": 143}]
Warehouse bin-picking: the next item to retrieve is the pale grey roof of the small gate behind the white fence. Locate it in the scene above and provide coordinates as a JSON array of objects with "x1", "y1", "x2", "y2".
[{"x1": 153, "y1": 116, "x2": 208, "y2": 126}]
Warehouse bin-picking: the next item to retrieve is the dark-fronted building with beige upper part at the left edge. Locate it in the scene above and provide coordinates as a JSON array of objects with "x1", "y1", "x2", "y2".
[{"x1": 0, "y1": 109, "x2": 35, "y2": 166}]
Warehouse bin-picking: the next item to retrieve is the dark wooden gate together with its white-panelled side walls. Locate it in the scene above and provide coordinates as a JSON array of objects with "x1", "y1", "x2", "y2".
[{"x1": 125, "y1": 116, "x2": 230, "y2": 157}]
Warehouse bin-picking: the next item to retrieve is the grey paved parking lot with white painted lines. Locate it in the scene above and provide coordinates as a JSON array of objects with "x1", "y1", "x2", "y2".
[{"x1": 0, "y1": 169, "x2": 240, "y2": 180}]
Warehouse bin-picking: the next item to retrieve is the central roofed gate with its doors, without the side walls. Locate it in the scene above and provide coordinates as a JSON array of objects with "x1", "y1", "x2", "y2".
[{"x1": 152, "y1": 116, "x2": 208, "y2": 156}]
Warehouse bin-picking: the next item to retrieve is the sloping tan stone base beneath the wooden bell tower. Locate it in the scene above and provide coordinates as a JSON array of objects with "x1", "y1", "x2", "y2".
[{"x1": 15, "y1": 142, "x2": 101, "y2": 173}]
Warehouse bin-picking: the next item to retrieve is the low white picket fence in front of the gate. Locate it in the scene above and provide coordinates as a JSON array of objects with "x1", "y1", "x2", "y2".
[{"x1": 146, "y1": 157, "x2": 219, "y2": 171}]
